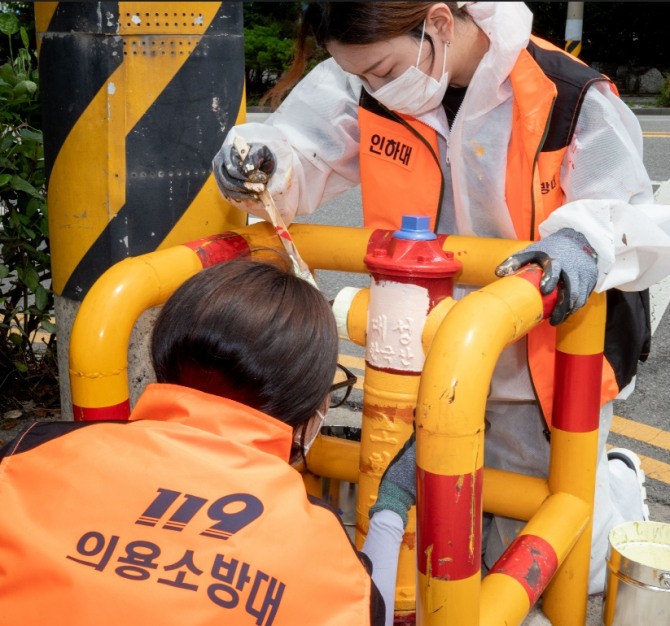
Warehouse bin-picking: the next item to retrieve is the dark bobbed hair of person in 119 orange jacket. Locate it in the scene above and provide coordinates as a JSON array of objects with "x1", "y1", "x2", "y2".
[{"x1": 151, "y1": 258, "x2": 338, "y2": 426}]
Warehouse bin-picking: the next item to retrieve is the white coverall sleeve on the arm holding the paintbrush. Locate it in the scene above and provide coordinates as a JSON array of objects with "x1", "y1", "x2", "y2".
[{"x1": 223, "y1": 59, "x2": 361, "y2": 224}]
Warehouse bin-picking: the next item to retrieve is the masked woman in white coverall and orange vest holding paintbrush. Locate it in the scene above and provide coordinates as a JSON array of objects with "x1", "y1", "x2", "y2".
[{"x1": 213, "y1": 2, "x2": 670, "y2": 593}]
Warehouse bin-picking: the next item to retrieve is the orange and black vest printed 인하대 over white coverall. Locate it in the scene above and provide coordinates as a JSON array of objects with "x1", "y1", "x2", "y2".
[{"x1": 358, "y1": 37, "x2": 650, "y2": 425}]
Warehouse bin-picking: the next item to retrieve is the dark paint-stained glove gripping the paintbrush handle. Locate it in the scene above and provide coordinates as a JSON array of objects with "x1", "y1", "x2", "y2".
[{"x1": 212, "y1": 143, "x2": 277, "y2": 200}]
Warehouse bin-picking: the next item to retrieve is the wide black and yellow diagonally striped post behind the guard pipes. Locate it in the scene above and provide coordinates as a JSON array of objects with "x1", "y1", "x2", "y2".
[{"x1": 35, "y1": 2, "x2": 246, "y2": 416}]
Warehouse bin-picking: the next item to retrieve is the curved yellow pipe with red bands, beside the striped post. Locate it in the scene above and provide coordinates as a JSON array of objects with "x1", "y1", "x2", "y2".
[{"x1": 69, "y1": 223, "x2": 306, "y2": 420}]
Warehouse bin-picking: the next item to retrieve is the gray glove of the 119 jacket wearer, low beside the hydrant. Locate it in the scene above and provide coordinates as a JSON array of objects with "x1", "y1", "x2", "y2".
[{"x1": 370, "y1": 433, "x2": 416, "y2": 528}]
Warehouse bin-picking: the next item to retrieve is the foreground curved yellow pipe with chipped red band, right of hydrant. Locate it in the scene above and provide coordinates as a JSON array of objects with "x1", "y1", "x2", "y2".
[{"x1": 416, "y1": 269, "x2": 543, "y2": 626}]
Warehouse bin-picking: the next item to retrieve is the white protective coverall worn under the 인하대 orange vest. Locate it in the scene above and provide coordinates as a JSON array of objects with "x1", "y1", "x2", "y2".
[{"x1": 217, "y1": 2, "x2": 670, "y2": 593}]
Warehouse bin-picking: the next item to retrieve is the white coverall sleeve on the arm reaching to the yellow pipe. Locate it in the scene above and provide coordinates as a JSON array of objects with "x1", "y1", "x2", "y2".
[{"x1": 540, "y1": 79, "x2": 670, "y2": 292}]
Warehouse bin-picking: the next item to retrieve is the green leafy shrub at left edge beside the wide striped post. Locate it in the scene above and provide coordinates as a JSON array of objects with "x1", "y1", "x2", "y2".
[{"x1": 0, "y1": 5, "x2": 56, "y2": 396}]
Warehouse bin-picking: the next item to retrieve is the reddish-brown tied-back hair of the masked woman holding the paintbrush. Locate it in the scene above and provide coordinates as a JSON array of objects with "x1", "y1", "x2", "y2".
[{"x1": 261, "y1": 0, "x2": 470, "y2": 107}]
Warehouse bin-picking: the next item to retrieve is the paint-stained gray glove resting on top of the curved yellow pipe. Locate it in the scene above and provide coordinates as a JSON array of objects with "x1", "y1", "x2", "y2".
[{"x1": 496, "y1": 228, "x2": 598, "y2": 326}]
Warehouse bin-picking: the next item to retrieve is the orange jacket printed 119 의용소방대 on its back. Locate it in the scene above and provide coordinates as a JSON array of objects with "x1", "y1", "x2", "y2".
[{"x1": 0, "y1": 384, "x2": 383, "y2": 626}]
